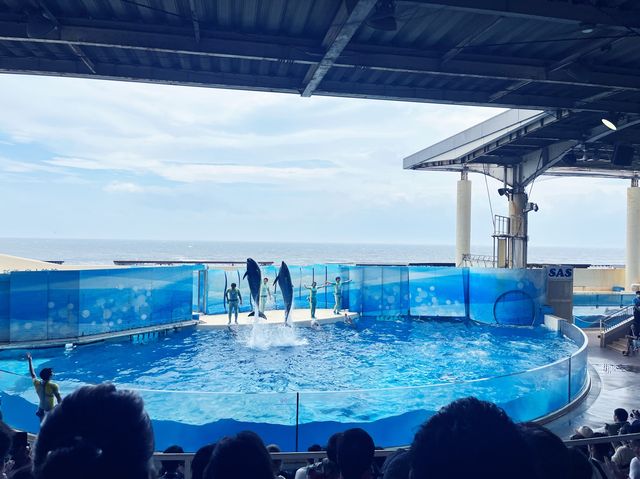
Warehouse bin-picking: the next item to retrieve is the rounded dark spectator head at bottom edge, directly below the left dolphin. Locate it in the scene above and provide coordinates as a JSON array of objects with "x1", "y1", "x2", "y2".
[{"x1": 204, "y1": 431, "x2": 273, "y2": 479}]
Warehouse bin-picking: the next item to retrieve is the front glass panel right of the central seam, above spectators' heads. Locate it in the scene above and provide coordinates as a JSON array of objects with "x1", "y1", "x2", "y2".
[{"x1": 299, "y1": 358, "x2": 569, "y2": 449}]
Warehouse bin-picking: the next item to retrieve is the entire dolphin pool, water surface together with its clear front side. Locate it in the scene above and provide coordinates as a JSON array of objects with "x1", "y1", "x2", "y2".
[{"x1": 0, "y1": 317, "x2": 586, "y2": 450}]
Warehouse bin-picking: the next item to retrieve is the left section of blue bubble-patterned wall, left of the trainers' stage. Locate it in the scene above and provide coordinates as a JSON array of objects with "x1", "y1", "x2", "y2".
[{"x1": 0, "y1": 266, "x2": 197, "y2": 342}]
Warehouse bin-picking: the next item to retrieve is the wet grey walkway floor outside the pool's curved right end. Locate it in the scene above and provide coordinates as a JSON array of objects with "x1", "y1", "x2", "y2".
[{"x1": 545, "y1": 330, "x2": 640, "y2": 439}]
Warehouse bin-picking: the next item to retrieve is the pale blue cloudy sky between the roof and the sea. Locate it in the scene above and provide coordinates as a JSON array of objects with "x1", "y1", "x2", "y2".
[{"x1": 0, "y1": 74, "x2": 628, "y2": 252}]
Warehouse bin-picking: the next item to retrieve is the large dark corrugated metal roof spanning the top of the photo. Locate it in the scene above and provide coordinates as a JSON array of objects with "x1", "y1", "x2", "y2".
[{"x1": 0, "y1": 0, "x2": 640, "y2": 113}]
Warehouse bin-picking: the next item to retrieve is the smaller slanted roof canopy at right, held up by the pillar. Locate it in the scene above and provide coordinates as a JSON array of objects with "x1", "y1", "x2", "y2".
[{"x1": 404, "y1": 110, "x2": 640, "y2": 186}]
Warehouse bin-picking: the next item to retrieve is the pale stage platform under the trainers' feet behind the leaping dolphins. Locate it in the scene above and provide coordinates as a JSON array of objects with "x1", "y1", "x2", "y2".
[{"x1": 198, "y1": 309, "x2": 358, "y2": 329}]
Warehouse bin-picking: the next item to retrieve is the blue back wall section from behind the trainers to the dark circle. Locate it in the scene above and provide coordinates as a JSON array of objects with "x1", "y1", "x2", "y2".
[{"x1": 206, "y1": 264, "x2": 549, "y2": 326}]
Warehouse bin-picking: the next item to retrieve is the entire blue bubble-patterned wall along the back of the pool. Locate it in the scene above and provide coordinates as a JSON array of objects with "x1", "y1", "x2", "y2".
[{"x1": 0, "y1": 264, "x2": 552, "y2": 342}]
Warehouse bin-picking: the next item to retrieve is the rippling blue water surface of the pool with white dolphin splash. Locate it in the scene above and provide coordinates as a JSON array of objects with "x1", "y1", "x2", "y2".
[{"x1": 0, "y1": 318, "x2": 576, "y2": 414}]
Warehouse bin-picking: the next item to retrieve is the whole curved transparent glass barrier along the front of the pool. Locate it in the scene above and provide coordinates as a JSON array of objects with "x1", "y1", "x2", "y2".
[{"x1": 0, "y1": 324, "x2": 588, "y2": 451}]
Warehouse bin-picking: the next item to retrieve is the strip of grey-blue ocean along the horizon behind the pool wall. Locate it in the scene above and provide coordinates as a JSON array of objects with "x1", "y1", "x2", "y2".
[{"x1": 0, "y1": 238, "x2": 625, "y2": 265}]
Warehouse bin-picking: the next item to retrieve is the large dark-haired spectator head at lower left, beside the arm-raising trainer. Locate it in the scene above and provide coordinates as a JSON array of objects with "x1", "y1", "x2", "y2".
[{"x1": 33, "y1": 384, "x2": 154, "y2": 479}]
